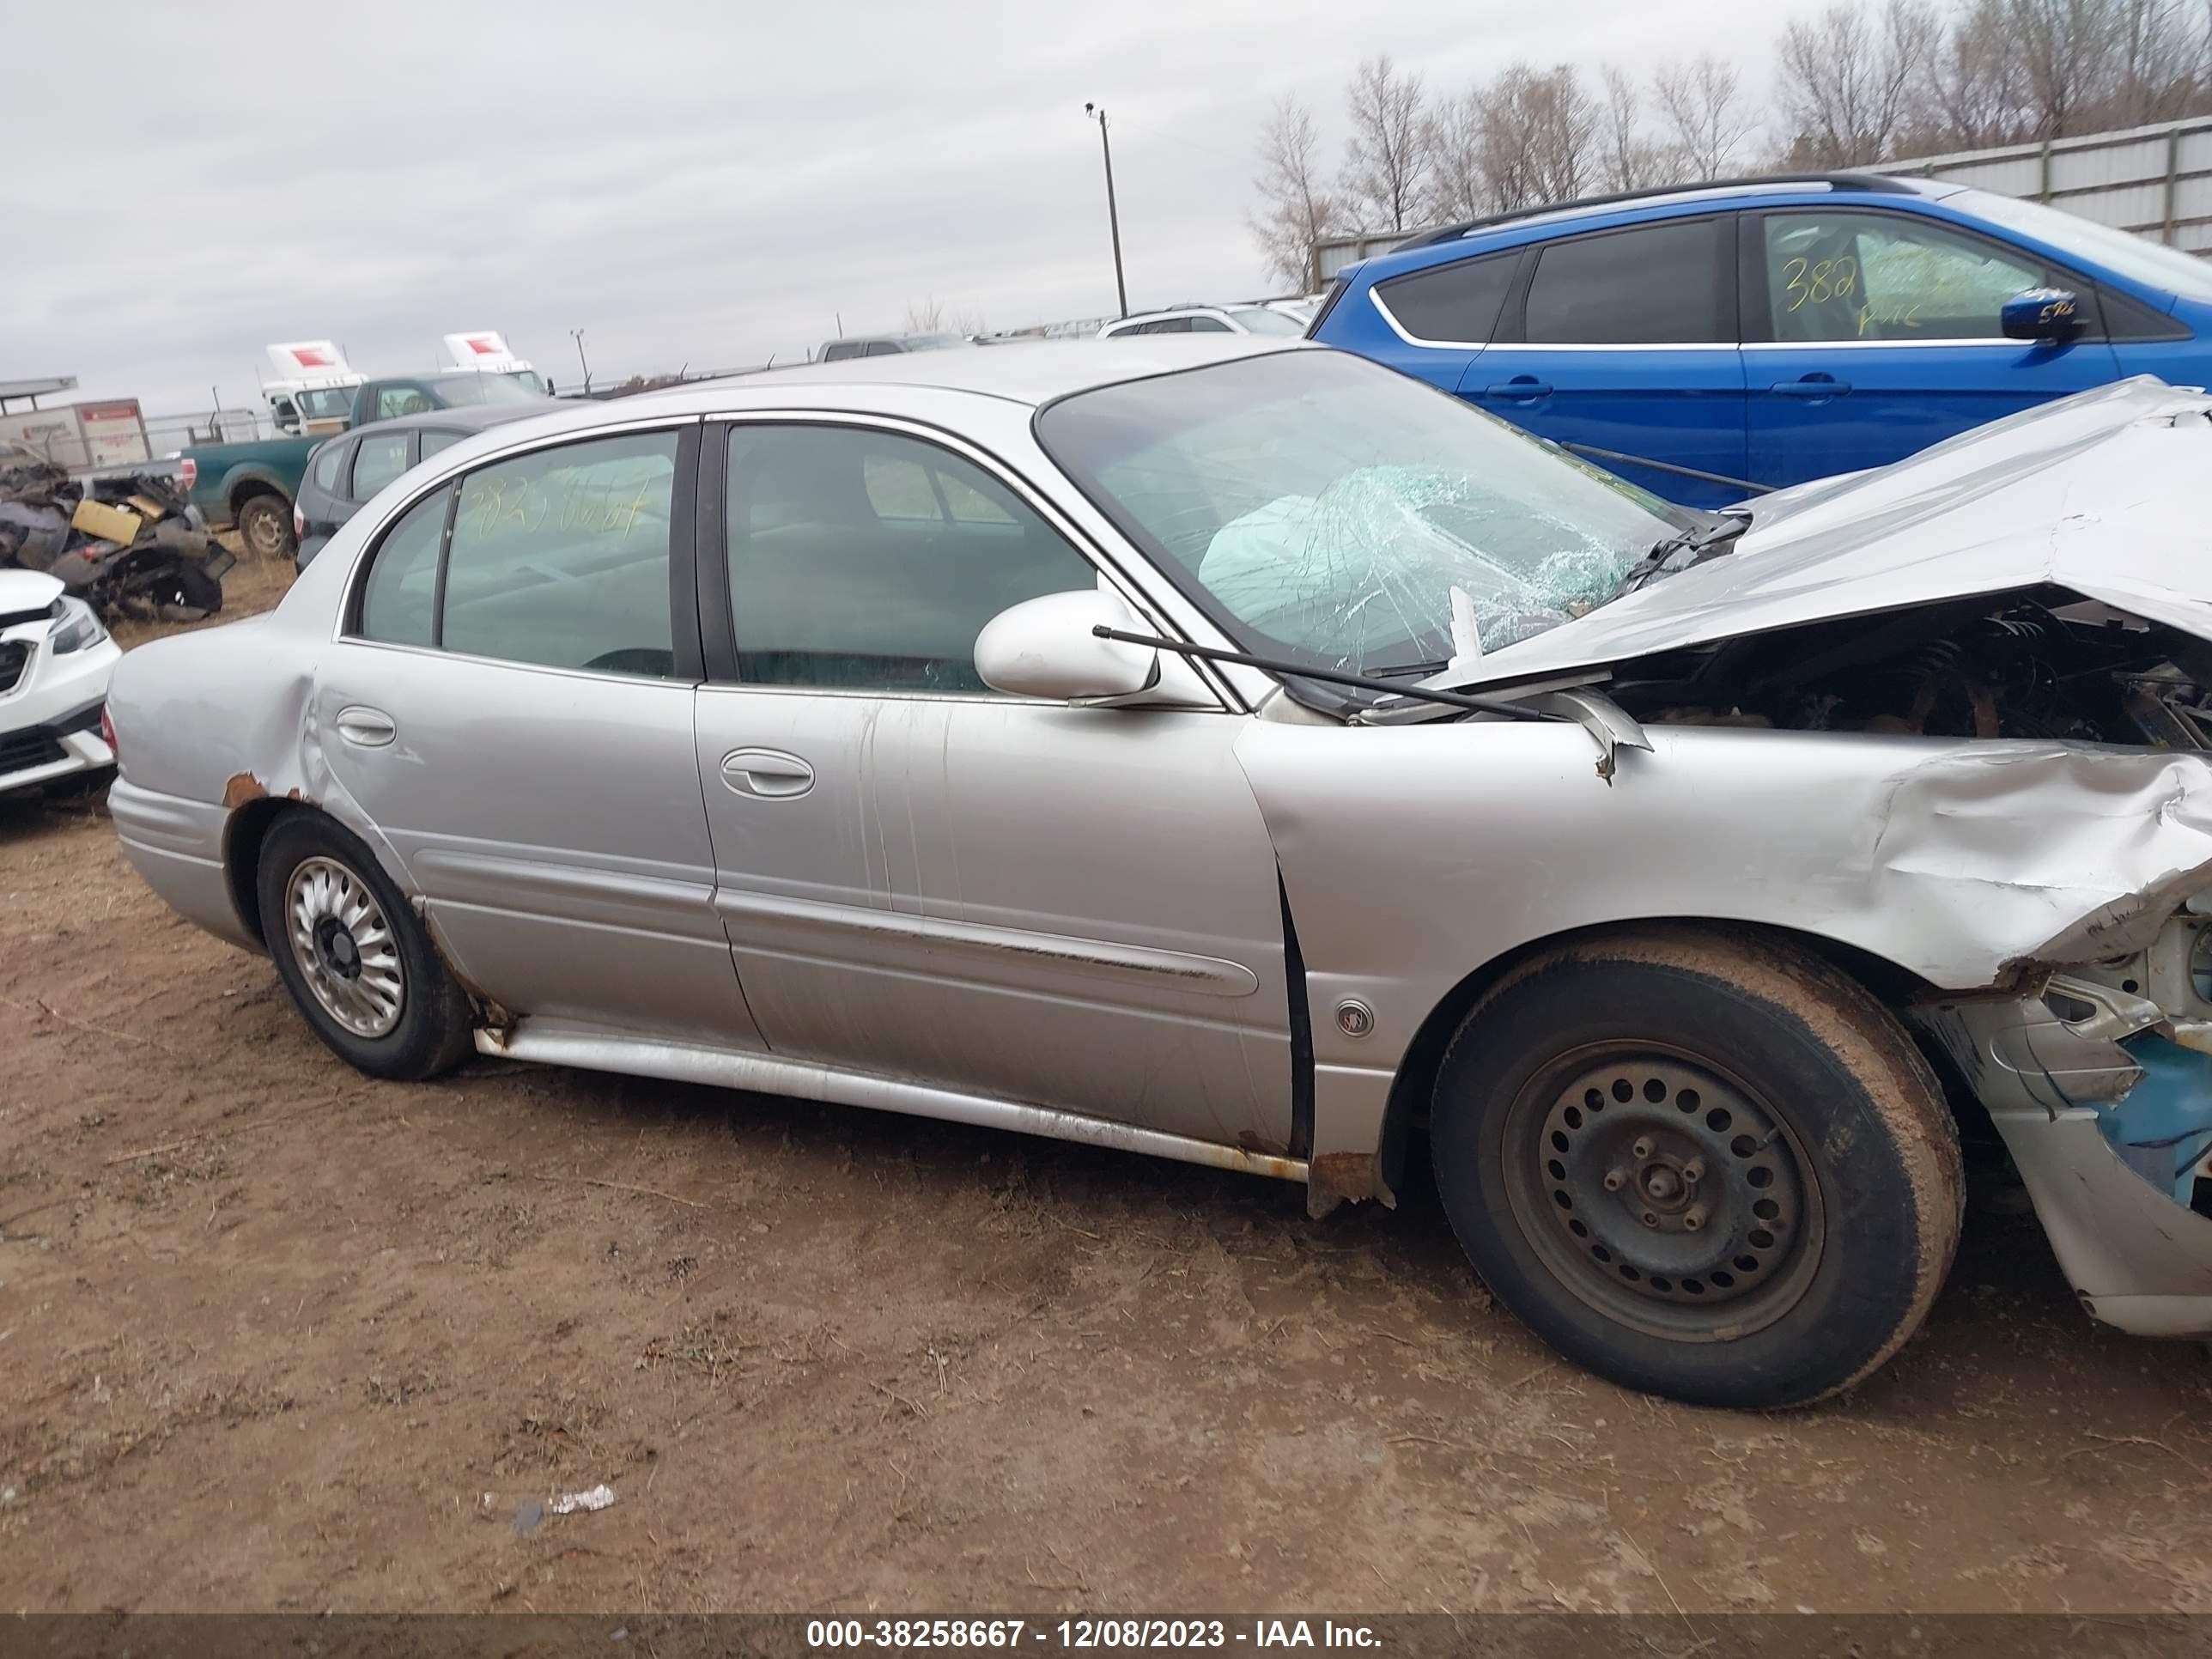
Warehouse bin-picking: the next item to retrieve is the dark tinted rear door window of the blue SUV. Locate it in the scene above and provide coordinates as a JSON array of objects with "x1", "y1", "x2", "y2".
[{"x1": 1524, "y1": 219, "x2": 1736, "y2": 345}]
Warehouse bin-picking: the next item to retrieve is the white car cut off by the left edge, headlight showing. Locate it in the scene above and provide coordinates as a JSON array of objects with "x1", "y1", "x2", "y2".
[{"x1": 0, "y1": 571, "x2": 124, "y2": 794}]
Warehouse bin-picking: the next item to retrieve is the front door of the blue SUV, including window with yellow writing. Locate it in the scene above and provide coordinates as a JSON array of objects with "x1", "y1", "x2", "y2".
[{"x1": 1743, "y1": 206, "x2": 2119, "y2": 487}]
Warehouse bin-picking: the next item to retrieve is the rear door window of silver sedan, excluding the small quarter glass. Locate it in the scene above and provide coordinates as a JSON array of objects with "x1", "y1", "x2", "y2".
[{"x1": 438, "y1": 431, "x2": 677, "y2": 677}]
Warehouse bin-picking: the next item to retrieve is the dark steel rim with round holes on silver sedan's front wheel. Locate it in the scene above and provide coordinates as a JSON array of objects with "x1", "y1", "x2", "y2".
[{"x1": 1504, "y1": 1044, "x2": 1825, "y2": 1340}]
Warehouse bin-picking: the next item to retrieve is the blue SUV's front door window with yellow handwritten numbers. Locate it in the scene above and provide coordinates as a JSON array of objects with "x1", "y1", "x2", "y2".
[{"x1": 1760, "y1": 210, "x2": 2046, "y2": 341}]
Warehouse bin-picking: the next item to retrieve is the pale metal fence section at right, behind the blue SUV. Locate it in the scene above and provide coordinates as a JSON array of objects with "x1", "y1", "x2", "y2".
[{"x1": 1869, "y1": 115, "x2": 2212, "y2": 254}]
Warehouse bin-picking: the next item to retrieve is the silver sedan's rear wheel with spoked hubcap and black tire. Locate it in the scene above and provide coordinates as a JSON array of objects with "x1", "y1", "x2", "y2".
[{"x1": 254, "y1": 810, "x2": 476, "y2": 1082}]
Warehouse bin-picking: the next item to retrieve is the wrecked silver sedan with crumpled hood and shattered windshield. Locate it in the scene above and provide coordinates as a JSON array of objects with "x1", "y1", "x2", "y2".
[{"x1": 108, "y1": 338, "x2": 2212, "y2": 1407}]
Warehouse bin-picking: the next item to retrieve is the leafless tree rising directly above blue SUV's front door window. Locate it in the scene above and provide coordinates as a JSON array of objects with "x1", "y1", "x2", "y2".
[{"x1": 1777, "y1": 0, "x2": 1942, "y2": 168}]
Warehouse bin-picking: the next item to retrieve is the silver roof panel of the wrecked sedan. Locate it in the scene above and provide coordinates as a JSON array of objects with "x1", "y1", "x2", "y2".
[{"x1": 602, "y1": 334, "x2": 1301, "y2": 420}]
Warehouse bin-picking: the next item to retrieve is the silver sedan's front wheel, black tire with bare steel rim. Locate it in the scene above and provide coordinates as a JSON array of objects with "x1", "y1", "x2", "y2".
[{"x1": 1431, "y1": 931, "x2": 1964, "y2": 1409}]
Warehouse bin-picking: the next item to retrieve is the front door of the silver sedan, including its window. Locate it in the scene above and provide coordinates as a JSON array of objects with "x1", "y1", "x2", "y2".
[{"x1": 699, "y1": 422, "x2": 1290, "y2": 1151}]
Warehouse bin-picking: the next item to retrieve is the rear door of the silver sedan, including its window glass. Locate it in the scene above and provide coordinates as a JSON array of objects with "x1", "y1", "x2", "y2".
[{"x1": 314, "y1": 427, "x2": 759, "y2": 1046}]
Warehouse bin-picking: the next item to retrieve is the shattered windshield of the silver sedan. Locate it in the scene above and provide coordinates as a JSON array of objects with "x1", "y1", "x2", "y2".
[{"x1": 1037, "y1": 352, "x2": 1697, "y2": 675}]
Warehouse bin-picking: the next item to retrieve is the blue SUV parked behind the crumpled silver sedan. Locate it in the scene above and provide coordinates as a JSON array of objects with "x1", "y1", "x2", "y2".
[{"x1": 1312, "y1": 175, "x2": 2212, "y2": 507}]
